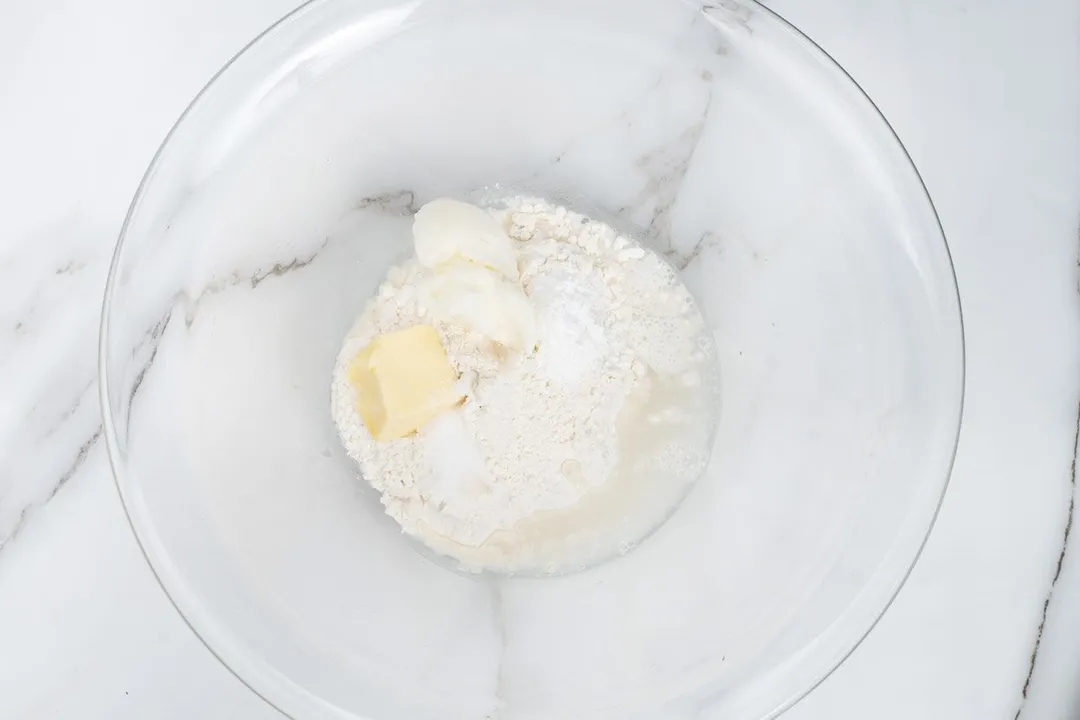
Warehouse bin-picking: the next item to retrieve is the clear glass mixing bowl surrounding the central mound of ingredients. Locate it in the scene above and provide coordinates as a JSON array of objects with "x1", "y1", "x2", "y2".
[{"x1": 100, "y1": 0, "x2": 963, "y2": 720}]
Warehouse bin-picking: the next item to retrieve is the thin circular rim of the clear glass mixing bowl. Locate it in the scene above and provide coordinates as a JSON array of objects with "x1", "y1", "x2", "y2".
[{"x1": 97, "y1": 0, "x2": 967, "y2": 720}]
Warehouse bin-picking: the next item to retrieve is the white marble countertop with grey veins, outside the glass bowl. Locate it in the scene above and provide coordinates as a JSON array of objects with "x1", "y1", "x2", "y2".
[{"x1": 0, "y1": 0, "x2": 1080, "y2": 720}]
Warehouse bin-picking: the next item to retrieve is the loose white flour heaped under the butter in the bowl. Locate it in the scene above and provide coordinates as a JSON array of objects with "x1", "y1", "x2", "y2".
[{"x1": 332, "y1": 199, "x2": 711, "y2": 570}]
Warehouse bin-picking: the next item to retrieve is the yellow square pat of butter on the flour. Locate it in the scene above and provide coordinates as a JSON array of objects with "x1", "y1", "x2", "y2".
[{"x1": 348, "y1": 325, "x2": 462, "y2": 440}]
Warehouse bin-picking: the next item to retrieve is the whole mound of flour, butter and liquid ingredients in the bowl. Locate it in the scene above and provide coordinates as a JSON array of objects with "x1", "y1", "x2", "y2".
[{"x1": 332, "y1": 198, "x2": 718, "y2": 573}]
